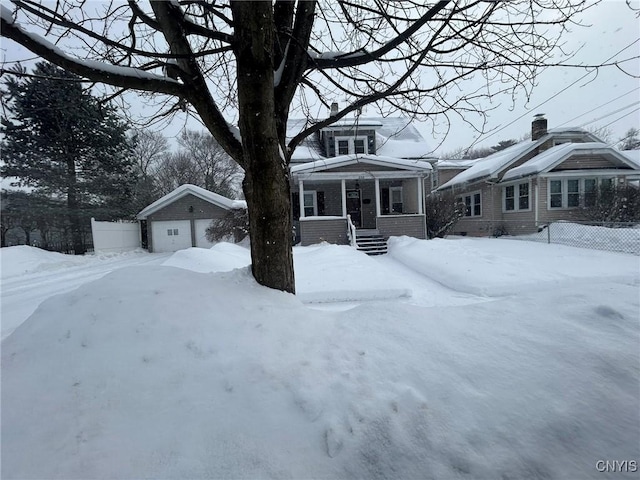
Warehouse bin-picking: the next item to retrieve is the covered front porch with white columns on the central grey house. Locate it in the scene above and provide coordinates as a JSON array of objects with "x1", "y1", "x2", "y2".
[{"x1": 291, "y1": 156, "x2": 431, "y2": 245}]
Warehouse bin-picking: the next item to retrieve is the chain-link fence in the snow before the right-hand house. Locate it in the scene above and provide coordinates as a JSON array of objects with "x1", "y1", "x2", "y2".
[{"x1": 452, "y1": 219, "x2": 640, "y2": 256}]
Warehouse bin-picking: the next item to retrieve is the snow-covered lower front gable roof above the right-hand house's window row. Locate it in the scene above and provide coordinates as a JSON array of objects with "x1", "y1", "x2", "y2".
[{"x1": 502, "y1": 142, "x2": 640, "y2": 180}]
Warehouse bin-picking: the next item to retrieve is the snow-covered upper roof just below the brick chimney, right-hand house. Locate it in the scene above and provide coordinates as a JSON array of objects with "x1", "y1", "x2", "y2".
[{"x1": 437, "y1": 127, "x2": 600, "y2": 190}]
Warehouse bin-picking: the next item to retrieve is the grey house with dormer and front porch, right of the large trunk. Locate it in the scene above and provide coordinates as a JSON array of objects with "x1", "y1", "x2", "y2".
[{"x1": 288, "y1": 109, "x2": 431, "y2": 253}]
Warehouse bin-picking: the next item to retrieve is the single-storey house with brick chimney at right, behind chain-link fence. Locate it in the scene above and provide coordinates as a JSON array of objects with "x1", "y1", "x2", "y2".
[{"x1": 435, "y1": 115, "x2": 640, "y2": 235}]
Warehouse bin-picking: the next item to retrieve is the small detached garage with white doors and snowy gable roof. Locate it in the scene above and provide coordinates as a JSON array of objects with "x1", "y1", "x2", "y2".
[{"x1": 138, "y1": 184, "x2": 246, "y2": 252}]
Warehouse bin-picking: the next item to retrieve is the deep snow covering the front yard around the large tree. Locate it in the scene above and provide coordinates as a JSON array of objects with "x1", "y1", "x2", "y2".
[{"x1": 2, "y1": 237, "x2": 640, "y2": 479}]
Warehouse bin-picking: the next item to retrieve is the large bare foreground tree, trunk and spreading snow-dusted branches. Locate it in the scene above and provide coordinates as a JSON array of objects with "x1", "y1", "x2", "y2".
[{"x1": 0, "y1": 0, "x2": 634, "y2": 292}]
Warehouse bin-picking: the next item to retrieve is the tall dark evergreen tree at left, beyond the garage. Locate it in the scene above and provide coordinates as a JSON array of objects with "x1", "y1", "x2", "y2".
[{"x1": 0, "y1": 63, "x2": 133, "y2": 254}]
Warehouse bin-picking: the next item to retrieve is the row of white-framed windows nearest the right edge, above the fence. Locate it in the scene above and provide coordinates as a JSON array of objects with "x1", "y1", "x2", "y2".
[{"x1": 547, "y1": 178, "x2": 613, "y2": 206}]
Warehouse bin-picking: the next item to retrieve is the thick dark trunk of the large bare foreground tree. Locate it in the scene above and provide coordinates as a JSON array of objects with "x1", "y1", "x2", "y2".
[{"x1": 232, "y1": 1, "x2": 295, "y2": 293}]
